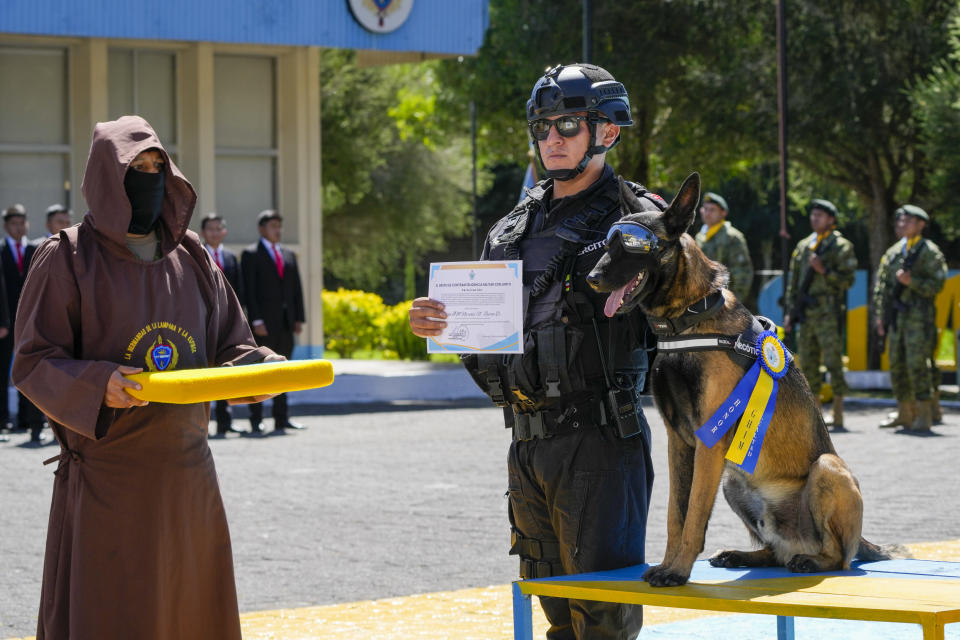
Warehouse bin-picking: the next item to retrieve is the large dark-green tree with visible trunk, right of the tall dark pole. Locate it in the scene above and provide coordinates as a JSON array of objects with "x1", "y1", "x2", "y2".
[{"x1": 788, "y1": 0, "x2": 956, "y2": 272}]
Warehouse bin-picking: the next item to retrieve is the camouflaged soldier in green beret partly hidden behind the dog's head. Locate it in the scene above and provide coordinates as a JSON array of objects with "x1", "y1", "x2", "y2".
[{"x1": 696, "y1": 192, "x2": 753, "y2": 304}]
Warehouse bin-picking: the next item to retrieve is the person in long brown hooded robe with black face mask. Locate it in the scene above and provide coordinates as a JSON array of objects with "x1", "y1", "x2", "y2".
[{"x1": 13, "y1": 116, "x2": 283, "y2": 640}]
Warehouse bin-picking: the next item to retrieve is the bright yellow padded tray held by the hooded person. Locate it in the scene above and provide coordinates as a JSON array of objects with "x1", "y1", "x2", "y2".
[{"x1": 126, "y1": 360, "x2": 333, "y2": 404}]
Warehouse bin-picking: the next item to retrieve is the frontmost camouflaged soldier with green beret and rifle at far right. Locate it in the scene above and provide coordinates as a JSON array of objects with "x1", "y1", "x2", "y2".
[{"x1": 873, "y1": 204, "x2": 947, "y2": 431}]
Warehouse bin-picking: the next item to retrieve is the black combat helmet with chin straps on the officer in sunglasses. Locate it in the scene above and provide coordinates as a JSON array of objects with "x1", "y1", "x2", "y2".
[{"x1": 527, "y1": 63, "x2": 633, "y2": 180}]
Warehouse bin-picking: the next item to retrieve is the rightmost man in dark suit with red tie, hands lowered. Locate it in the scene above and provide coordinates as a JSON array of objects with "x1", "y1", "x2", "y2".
[{"x1": 240, "y1": 209, "x2": 305, "y2": 434}]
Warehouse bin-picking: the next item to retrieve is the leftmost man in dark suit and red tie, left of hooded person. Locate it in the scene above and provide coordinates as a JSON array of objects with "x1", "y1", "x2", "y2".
[{"x1": 0, "y1": 204, "x2": 45, "y2": 443}]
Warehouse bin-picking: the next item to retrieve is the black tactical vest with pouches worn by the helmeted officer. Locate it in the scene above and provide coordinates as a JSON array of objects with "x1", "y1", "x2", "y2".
[{"x1": 463, "y1": 174, "x2": 665, "y2": 427}]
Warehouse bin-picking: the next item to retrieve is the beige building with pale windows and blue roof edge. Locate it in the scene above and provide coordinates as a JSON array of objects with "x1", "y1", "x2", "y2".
[{"x1": 0, "y1": 0, "x2": 489, "y2": 357}]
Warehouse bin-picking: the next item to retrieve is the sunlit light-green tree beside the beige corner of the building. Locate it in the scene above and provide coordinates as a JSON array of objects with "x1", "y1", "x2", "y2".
[{"x1": 321, "y1": 50, "x2": 471, "y2": 289}]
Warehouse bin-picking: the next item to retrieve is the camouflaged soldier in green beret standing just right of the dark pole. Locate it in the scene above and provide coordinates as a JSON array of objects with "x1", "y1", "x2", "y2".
[{"x1": 783, "y1": 199, "x2": 857, "y2": 431}]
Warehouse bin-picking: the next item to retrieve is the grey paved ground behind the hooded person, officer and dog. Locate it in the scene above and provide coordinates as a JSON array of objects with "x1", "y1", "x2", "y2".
[{"x1": 0, "y1": 361, "x2": 960, "y2": 640}]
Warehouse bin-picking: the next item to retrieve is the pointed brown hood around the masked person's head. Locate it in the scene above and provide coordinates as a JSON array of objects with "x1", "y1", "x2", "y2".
[{"x1": 81, "y1": 116, "x2": 197, "y2": 254}]
